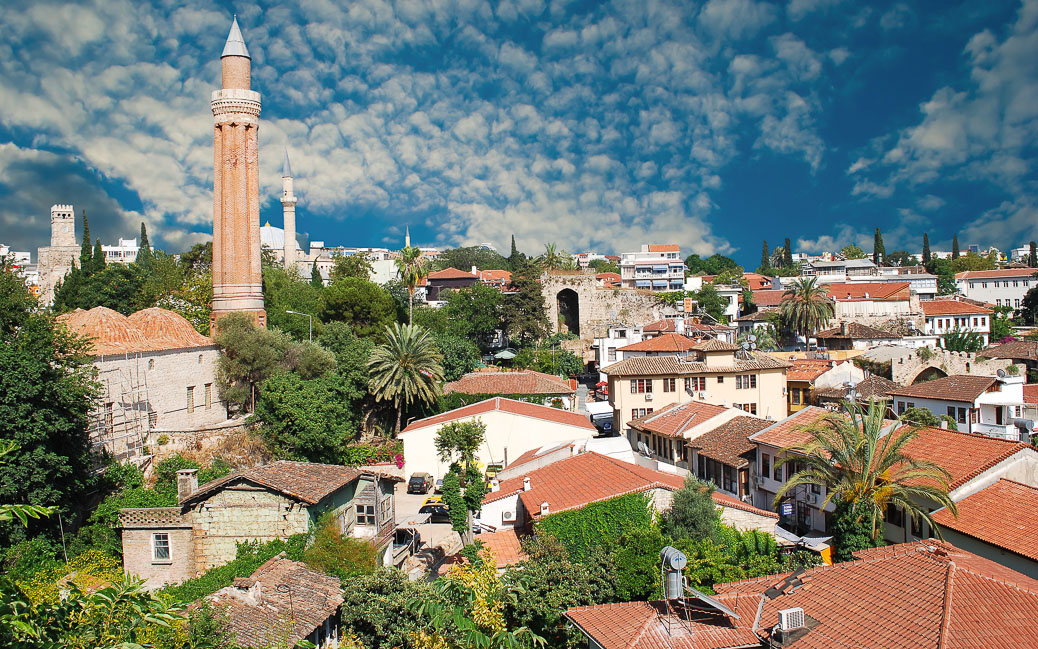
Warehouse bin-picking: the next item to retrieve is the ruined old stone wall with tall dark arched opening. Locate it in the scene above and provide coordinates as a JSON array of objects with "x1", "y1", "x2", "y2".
[{"x1": 541, "y1": 271, "x2": 677, "y2": 342}]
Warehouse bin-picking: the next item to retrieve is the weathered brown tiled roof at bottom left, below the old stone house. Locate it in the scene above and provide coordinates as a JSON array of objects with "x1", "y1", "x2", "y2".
[{"x1": 206, "y1": 552, "x2": 344, "y2": 647}]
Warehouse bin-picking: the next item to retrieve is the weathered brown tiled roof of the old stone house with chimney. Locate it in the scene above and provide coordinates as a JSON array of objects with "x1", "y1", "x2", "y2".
[{"x1": 181, "y1": 460, "x2": 392, "y2": 505}]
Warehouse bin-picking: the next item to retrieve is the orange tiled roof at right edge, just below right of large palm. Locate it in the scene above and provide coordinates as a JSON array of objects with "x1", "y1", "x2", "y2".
[{"x1": 933, "y1": 479, "x2": 1038, "y2": 561}]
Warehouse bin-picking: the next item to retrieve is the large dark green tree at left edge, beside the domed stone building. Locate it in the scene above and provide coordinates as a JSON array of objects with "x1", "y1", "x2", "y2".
[{"x1": 0, "y1": 267, "x2": 98, "y2": 545}]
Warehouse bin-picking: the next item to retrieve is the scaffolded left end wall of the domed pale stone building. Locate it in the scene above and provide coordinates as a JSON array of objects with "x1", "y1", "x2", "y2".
[{"x1": 89, "y1": 352, "x2": 152, "y2": 465}]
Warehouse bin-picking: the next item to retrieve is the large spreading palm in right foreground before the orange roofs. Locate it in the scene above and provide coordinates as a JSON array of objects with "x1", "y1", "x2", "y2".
[{"x1": 773, "y1": 401, "x2": 958, "y2": 540}]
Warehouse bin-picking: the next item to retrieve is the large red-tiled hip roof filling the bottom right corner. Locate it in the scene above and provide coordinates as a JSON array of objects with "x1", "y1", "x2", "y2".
[{"x1": 700, "y1": 540, "x2": 1038, "y2": 649}]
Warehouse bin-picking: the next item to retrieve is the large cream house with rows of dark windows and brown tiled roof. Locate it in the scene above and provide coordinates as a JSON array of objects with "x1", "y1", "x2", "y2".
[{"x1": 605, "y1": 340, "x2": 790, "y2": 431}]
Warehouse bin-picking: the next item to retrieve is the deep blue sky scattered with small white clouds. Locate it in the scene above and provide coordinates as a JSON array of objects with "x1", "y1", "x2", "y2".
[{"x1": 0, "y1": 0, "x2": 1038, "y2": 267}]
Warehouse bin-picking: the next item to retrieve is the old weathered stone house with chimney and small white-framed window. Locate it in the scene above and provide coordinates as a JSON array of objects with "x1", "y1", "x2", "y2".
[{"x1": 119, "y1": 460, "x2": 402, "y2": 588}]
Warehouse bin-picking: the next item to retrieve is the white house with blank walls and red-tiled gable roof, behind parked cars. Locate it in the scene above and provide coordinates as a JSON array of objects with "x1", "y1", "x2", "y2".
[{"x1": 400, "y1": 397, "x2": 597, "y2": 478}]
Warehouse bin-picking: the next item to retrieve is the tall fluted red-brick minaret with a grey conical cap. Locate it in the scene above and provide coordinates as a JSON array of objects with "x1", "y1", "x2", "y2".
[{"x1": 210, "y1": 18, "x2": 267, "y2": 334}]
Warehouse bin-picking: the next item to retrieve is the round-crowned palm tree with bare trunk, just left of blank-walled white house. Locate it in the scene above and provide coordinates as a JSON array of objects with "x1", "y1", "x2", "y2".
[{"x1": 367, "y1": 323, "x2": 443, "y2": 433}]
